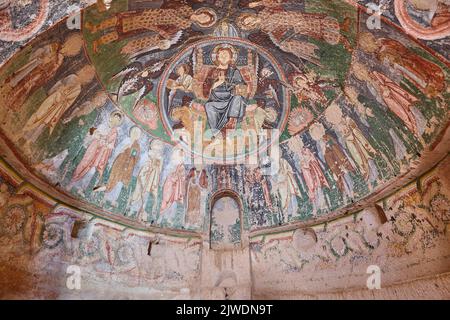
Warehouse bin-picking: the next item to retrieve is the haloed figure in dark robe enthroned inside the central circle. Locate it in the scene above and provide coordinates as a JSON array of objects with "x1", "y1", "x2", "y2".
[{"x1": 203, "y1": 45, "x2": 247, "y2": 136}]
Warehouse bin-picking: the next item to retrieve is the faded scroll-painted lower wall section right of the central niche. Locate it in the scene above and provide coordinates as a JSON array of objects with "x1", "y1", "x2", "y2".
[{"x1": 250, "y1": 158, "x2": 450, "y2": 299}]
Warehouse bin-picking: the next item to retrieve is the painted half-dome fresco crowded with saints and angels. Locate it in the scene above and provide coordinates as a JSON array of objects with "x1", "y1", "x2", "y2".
[{"x1": 0, "y1": 0, "x2": 449, "y2": 235}]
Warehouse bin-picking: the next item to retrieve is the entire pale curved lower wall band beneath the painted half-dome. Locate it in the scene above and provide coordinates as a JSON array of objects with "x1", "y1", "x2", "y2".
[{"x1": 0, "y1": 157, "x2": 450, "y2": 299}]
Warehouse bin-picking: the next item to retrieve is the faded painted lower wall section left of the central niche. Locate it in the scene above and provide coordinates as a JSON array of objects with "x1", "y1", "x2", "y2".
[{"x1": 0, "y1": 159, "x2": 201, "y2": 299}]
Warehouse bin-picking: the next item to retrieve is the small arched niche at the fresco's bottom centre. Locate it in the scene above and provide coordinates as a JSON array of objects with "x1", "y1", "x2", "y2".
[{"x1": 209, "y1": 190, "x2": 242, "y2": 250}]
